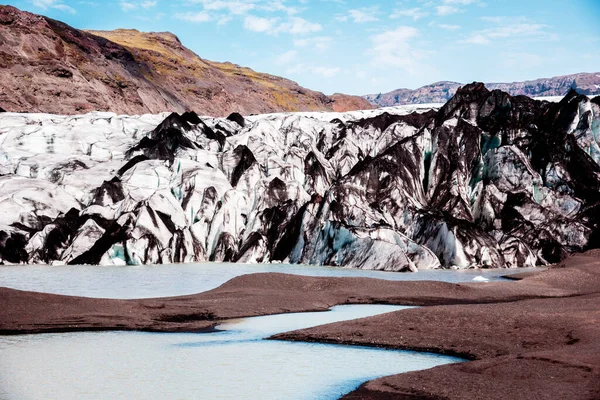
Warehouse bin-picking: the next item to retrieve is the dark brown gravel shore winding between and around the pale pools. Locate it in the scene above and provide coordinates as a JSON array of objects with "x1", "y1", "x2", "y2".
[{"x1": 0, "y1": 251, "x2": 600, "y2": 400}]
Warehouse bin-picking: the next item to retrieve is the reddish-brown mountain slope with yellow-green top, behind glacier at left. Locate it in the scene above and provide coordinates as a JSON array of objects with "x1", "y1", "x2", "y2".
[{"x1": 0, "y1": 6, "x2": 371, "y2": 116}]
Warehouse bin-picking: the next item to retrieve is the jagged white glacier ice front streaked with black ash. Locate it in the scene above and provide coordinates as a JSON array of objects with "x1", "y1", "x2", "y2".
[{"x1": 0, "y1": 84, "x2": 600, "y2": 271}]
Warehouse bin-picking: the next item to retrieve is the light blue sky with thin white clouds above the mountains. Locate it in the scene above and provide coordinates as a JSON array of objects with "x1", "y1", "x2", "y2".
[{"x1": 8, "y1": 0, "x2": 600, "y2": 95}]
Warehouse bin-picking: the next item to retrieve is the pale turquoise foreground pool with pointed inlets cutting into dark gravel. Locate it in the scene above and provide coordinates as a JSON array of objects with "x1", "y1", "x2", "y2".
[{"x1": 0, "y1": 305, "x2": 461, "y2": 400}]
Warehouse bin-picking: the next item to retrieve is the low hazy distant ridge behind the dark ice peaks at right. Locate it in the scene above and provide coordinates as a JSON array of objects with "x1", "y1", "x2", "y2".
[{"x1": 363, "y1": 72, "x2": 600, "y2": 107}]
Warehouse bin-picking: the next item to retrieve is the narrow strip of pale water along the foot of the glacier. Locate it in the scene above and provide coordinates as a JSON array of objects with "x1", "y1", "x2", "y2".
[{"x1": 0, "y1": 263, "x2": 526, "y2": 299}]
